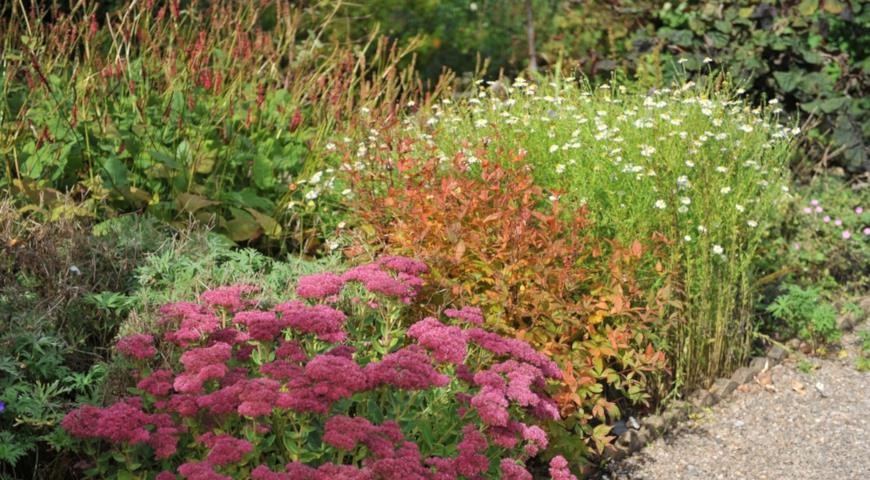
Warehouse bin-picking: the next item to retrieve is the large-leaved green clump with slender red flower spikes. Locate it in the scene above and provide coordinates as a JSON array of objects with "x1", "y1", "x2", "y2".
[{"x1": 0, "y1": 1, "x2": 450, "y2": 252}]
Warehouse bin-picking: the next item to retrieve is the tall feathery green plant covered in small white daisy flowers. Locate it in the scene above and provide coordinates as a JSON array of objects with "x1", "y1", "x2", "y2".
[{"x1": 378, "y1": 78, "x2": 796, "y2": 388}]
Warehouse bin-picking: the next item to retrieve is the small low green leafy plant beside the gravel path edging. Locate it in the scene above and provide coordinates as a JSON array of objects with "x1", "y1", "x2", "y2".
[{"x1": 767, "y1": 285, "x2": 840, "y2": 348}]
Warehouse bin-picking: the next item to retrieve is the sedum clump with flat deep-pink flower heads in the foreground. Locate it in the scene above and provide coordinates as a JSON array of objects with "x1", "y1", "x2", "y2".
[{"x1": 62, "y1": 257, "x2": 572, "y2": 480}]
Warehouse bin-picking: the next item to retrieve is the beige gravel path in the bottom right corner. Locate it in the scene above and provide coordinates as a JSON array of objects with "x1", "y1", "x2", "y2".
[{"x1": 604, "y1": 323, "x2": 870, "y2": 480}]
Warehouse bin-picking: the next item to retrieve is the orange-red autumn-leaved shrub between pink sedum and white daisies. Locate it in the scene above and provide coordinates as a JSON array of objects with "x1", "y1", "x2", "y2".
[{"x1": 354, "y1": 142, "x2": 665, "y2": 458}]
